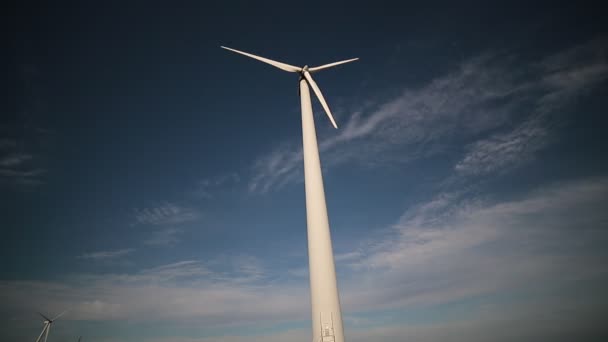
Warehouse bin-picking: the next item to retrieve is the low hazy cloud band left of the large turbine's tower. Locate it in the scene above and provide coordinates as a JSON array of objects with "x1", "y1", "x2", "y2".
[{"x1": 0, "y1": 257, "x2": 307, "y2": 326}]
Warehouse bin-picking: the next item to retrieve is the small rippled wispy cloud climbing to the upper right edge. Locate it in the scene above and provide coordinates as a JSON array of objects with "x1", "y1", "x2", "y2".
[{"x1": 455, "y1": 39, "x2": 608, "y2": 175}]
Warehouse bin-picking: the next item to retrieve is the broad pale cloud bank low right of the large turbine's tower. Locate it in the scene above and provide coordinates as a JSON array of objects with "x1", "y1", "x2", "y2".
[{"x1": 344, "y1": 179, "x2": 608, "y2": 311}]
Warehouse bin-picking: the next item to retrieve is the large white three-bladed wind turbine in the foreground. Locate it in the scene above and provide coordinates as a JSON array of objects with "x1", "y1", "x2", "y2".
[{"x1": 222, "y1": 46, "x2": 358, "y2": 342}]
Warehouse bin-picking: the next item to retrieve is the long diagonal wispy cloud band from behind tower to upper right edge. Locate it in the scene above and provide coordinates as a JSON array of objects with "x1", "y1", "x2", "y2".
[{"x1": 249, "y1": 40, "x2": 608, "y2": 193}]
